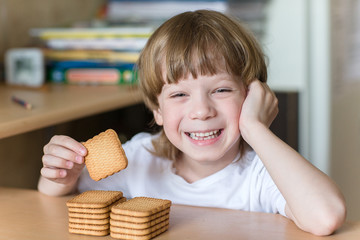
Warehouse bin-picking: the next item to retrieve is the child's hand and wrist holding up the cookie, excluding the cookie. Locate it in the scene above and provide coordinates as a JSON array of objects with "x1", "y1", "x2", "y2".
[{"x1": 38, "y1": 136, "x2": 87, "y2": 196}]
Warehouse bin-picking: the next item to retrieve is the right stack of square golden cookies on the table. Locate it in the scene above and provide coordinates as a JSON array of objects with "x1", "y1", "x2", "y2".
[{"x1": 110, "y1": 197, "x2": 171, "y2": 239}]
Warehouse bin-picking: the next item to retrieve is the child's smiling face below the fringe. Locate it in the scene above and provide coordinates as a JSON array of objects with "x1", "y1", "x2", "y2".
[{"x1": 154, "y1": 72, "x2": 246, "y2": 163}]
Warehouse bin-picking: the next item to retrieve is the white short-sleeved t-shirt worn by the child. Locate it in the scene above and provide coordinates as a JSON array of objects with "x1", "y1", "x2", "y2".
[{"x1": 78, "y1": 133, "x2": 286, "y2": 216}]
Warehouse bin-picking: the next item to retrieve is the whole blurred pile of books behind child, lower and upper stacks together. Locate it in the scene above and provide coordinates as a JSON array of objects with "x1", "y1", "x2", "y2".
[{"x1": 30, "y1": 0, "x2": 268, "y2": 84}]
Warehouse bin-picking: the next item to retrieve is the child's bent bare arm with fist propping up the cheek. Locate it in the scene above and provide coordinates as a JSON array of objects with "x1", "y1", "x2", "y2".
[{"x1": 239, "y1": 81, "x2": 346, "y2": 235}]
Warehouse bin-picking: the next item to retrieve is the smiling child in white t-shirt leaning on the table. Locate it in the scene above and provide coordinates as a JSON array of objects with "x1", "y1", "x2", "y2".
[{"x1": 38, "y1": 10, "x2": 346, "y2": 235}]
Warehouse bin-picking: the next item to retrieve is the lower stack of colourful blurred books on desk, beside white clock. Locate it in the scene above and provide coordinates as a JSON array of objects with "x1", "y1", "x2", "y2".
[{"x1": 30, "y1": 27, "x2": 153, "y2": 84}]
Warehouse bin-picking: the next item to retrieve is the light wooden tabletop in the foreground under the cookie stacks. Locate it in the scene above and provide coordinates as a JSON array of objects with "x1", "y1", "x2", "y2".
[{"x1": 0, "y1": 187, "x2": 360, "y2": 240}]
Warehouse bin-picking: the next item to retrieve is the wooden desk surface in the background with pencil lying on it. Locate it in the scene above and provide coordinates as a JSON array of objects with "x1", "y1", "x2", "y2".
[{"x1": 0, "y1": 84, "x2": 141, "y2": 139}]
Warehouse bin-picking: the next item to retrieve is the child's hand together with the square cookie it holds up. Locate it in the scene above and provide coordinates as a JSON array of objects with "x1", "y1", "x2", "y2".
[{"x1": 38, "y1": 129, "x2": 128, "y2": 196}]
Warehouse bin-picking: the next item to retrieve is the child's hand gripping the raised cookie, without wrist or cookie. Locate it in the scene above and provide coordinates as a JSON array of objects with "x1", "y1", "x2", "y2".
[{"x1": 41, "y1": 136, "x2": 87, "y2": 185}]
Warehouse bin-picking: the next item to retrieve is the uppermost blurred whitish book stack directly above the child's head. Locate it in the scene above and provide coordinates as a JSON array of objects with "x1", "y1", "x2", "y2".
[{"x1": 105, "y1": 0, "x2": 271, "y2": 38}]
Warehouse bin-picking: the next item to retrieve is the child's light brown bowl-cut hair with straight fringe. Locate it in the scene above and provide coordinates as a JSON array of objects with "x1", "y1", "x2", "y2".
[{"x1": 137, "y1": 10, "x2": 267, "y2": 160}]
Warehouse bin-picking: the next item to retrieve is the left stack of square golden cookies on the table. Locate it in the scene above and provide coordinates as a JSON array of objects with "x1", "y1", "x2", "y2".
[{"x1": 66, "y1": 191, "x2": 126, "y2": 236}]
